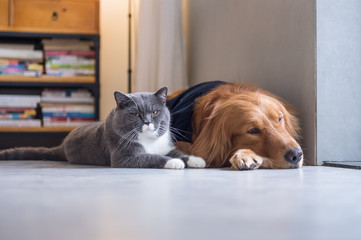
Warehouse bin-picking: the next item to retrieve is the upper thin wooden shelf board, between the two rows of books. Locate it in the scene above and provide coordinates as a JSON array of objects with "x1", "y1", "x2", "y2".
[{"x1": 0, "y1": 75, "x2": 95, "y2": 83}]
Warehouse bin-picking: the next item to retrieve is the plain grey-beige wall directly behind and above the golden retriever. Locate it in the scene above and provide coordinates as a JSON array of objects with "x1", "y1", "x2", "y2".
[{"x1": 188, "y1": 0, "x2": 316, "y2": 164}]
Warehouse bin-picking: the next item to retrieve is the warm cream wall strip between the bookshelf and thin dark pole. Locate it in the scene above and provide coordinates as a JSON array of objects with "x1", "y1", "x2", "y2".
[{"x1": 100, "y1": 0, "x2": 128, "y2": 120}]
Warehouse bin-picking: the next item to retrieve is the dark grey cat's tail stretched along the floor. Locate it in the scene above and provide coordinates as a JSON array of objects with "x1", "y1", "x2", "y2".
[{"x1": 0, "y1": 145, "x2": 67, "y2": 161}]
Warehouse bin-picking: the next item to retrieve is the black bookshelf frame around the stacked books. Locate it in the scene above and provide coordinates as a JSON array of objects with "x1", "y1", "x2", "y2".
[{"x1": 0, "y1": 28, "x2": 100, "y2": 149}]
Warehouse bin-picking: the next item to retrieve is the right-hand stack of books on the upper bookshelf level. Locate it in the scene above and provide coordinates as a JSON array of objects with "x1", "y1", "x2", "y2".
[{"x1": 42, "y1": 39, "x2": 95, "y2": 76}]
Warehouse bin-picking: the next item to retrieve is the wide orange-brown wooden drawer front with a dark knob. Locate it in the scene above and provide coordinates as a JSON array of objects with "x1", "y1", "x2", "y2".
[{"x1": 10, "y1": 0, "x2": 99, "y2": 33}]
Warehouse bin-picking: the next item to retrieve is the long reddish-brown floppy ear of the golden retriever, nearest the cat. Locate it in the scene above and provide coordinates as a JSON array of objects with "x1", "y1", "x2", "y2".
[{"x1": 191, "y1": 104, "x2": 232, "y2": 167}]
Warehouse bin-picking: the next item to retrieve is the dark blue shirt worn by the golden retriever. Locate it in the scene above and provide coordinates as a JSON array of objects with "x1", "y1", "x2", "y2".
[{"x1": 167, "y1": 81, "x2": 226, "y2": 143}]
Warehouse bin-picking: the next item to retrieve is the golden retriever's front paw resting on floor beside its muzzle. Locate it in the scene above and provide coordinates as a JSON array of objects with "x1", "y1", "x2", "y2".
[{"x1": 229, "y1": 149, "x2": 263, "y2": 170}]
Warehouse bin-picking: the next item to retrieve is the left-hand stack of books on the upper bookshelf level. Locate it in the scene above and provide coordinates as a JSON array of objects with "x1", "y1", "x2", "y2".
[{"x1": 0, "y1": 43, "x2": 44, "y2": 76}]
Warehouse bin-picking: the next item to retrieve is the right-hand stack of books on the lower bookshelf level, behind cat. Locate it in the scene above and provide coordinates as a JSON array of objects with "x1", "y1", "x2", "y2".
[{"x1": 41, "y1": 89, "x2": 94, "y2": 127}]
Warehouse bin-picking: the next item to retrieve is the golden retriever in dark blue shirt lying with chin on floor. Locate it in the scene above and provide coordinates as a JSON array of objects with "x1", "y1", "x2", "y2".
[{"x1": 167, "y1": 81, "x2": 303, "y2": 170}]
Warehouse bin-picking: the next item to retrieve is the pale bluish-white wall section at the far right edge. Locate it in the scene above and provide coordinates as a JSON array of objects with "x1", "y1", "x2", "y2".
[{"x1": 317, "y1": 0, "x2": 361, "y2": 164}]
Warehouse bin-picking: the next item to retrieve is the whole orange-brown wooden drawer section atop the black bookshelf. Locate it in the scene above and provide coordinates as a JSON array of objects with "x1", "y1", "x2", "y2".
[{"x1": 0, "y1": 0, "x2": 99, "y2": 34}]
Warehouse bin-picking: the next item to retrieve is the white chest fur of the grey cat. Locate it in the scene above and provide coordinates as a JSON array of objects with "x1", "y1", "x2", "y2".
[{"x1": 138, "y1": 128, "x2": 174, "y2": 155}]
